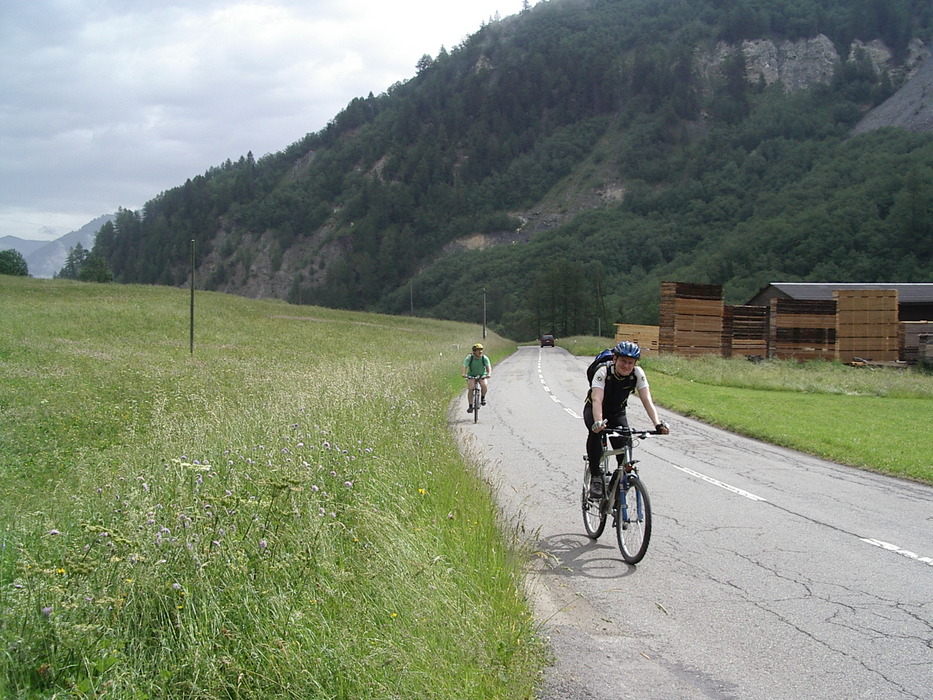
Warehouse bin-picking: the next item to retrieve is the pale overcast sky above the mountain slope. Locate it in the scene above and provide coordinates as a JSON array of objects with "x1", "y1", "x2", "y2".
[{"x1": 0, "y1": 0, "x2": 524, "y2": 240}]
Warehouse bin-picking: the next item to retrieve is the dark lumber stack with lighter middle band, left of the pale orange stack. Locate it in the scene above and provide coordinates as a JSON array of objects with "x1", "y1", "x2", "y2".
[{"x1": 768, "y1": 299, "x2": 836, "y2": 360}]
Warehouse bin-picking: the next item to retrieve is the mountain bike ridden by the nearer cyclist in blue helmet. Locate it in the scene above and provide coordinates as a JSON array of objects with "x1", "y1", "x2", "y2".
[{"x1": 581, "y1": 428, "x2": 662, "y2": 564}]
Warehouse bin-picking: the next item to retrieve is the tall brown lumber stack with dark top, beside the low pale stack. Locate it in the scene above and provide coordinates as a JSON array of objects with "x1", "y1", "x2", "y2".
[{"x1": 658, "y1": 282, "x2": 723, "y2": 356}]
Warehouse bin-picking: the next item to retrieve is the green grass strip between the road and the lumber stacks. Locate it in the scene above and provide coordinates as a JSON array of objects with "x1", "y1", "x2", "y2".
[{"x1": 558, "y1": 337, "x2": 933, "y2": 484}]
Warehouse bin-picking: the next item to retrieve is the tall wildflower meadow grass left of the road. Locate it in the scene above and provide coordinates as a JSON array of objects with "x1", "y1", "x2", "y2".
[{"x1": 0, "y1": 277, "x2": 544, "y2": 698}]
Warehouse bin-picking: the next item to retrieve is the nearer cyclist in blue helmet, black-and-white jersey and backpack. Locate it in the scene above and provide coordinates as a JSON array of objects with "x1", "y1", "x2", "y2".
[{"x1": 583, "y1": 340, "x2": 670, "y2": 498}]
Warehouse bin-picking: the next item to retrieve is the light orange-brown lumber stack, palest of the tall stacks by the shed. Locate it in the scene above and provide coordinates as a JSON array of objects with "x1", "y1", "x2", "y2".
[{"x1": 833, "y1": 289, "x2": 900, "y2": 362}]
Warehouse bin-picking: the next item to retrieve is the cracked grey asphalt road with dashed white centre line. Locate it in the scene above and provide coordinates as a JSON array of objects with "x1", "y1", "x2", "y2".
[{"x1": 451, "y1": 347, "x2": 933, "y2": 700}]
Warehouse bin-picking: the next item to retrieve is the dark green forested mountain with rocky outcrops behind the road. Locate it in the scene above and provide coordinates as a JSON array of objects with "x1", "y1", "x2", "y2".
[{"x1": 93, "y1": 0, "x2": 933, "y2": 340}]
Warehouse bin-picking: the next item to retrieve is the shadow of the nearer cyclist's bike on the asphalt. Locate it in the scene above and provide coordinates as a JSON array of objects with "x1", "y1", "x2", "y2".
[{"x1": 538, "y1": 523, "x2": 637, "y2": 579}]
